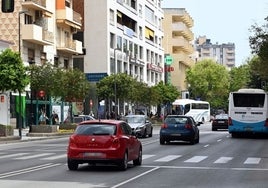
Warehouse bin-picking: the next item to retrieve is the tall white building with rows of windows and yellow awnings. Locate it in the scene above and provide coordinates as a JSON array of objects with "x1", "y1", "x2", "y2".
[{"x1": 84, "y1": 0, "x2": 164, "y2": 86}]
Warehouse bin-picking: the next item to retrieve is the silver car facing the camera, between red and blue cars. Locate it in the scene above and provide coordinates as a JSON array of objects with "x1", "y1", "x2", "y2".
[{"x1": 124, "y1": 114, "x2": 153, "y2": 138}]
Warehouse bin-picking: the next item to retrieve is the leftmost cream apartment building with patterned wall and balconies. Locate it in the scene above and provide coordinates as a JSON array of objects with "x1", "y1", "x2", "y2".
[{"x1": 0, "y1": 0, "x2": 83, "y2": 68}]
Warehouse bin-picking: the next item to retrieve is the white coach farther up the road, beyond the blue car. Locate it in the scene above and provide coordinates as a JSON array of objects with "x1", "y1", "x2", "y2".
[{"x1": 172, "y1": 99, "x2": 210, "y2": 123}]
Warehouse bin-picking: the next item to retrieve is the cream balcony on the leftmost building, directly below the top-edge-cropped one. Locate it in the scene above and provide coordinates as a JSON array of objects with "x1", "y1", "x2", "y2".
[{"x1": 21, "y1": 24, "x2": 54, "y2": 46}]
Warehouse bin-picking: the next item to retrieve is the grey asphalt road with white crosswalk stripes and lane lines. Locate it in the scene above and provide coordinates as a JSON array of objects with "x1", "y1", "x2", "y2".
[{"x1": 0, "y1": 124, "x2": 268, "y2": 188}]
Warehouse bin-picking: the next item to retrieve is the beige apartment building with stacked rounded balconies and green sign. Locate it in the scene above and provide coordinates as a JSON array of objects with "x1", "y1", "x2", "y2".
[{"x1": 163, "y1": 8, "x2": 195, "y2": 91}]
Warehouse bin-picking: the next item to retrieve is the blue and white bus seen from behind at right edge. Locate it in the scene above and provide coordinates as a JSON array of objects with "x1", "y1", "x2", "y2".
[{"x1": 228, "y1": 89, "x2": 268, "y2": 137}]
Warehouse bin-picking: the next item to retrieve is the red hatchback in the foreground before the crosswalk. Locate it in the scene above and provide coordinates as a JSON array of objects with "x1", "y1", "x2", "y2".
[{"x1": 67, "y1": 120, "x2": 142, "y2": 170}]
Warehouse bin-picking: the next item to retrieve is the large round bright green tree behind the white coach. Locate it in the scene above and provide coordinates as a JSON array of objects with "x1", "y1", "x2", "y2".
[{"x1": 186, "y1": 59, "x2": 230, "y2": 108}]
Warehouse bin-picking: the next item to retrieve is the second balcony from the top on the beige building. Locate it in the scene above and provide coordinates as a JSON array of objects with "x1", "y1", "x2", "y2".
[{"x1": 172, "y1": 22, "x2": 194, "y2": 41}]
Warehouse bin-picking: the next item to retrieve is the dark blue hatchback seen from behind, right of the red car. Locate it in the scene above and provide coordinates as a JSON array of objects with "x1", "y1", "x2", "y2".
[{"x1": 160, "y1": 115, "x2": 200, "y2": 145}]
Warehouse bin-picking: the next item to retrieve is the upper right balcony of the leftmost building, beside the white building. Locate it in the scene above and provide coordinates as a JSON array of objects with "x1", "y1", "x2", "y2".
[{"x1": 56, "y1": 7, "x2": 82, "y2": 29}]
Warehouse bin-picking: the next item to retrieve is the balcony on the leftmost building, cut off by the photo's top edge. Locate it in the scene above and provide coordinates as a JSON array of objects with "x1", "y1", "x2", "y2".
[{"x1": 21, "y1": 0, "x2": 53, "y2": 17}]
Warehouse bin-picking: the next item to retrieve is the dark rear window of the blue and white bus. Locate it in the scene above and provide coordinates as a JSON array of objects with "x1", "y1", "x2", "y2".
[{"x1": 233, "y1": 93, "x2": 265, "y2": 108}]
